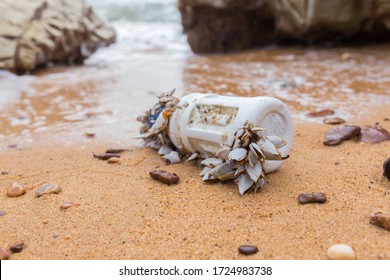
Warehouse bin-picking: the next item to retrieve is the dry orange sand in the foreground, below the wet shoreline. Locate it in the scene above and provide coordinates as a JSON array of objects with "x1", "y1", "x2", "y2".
[{"x1": 0, "y1": 106, "x2": 390, "y2": 260}]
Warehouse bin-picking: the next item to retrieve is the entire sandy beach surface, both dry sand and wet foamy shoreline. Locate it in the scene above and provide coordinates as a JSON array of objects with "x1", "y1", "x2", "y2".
[{"x1": 0, "y1": 46, "x2": 390, "y2": 260}]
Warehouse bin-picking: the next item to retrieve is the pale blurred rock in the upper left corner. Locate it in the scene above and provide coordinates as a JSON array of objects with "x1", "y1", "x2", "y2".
[{"x1": 0, "y1": 0, "x2": 115, "y2": 74}]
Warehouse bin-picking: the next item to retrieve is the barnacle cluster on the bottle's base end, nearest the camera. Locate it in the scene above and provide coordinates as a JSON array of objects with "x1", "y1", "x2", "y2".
[{"x1": 200, "y1": 122, "x2": 287, "y2": 195}]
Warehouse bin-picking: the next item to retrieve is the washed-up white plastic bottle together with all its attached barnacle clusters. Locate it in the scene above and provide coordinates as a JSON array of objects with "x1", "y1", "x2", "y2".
[{"x1": 137, "y1": 90, "x2": 293, "y2": 194}]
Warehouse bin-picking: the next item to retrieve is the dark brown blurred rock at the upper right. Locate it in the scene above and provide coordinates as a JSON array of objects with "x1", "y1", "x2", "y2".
[{"x1": 178, "y1": 0, "x2": 390, "y2": 53}]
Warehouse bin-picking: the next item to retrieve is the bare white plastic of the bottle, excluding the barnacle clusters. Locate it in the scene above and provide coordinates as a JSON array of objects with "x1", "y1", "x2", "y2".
[{"x1": 169, "y1": 93, "x2": 294, "y2": 173}]
